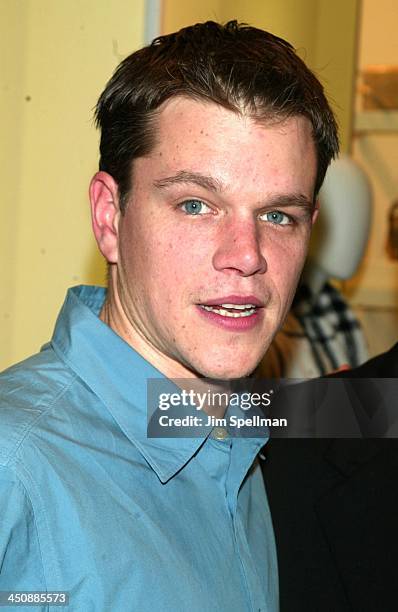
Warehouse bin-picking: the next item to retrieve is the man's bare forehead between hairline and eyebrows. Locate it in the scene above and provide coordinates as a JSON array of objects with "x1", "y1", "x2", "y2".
[{"x1": 136, "y1": 97, "x2": 316, "y2": 195}]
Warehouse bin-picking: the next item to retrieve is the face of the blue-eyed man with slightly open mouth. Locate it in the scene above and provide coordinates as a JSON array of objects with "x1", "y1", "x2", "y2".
[{"x1": 102, "y1": 98, "x2": 317, "y2": 378}]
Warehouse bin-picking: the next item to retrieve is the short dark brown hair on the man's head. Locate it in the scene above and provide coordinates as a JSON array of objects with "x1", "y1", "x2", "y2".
[{"x1": 95, "y1": 21, "x2": 338, "y2": 212}]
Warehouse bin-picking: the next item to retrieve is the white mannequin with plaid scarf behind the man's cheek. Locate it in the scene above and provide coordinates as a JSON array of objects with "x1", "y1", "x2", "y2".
[{"x1": 258, "y1": 156, "x2": 372, "y2": 378}]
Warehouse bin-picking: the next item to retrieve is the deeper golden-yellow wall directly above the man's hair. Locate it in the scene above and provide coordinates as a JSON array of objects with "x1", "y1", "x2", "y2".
[{"x1": 163, "y1": 0, "x2": 358, "y2": 150}]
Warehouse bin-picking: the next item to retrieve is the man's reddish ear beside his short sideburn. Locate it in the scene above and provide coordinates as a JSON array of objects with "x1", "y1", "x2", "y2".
[{"x1": 89, "y1": 171, "x2": 120, "y2": 263}]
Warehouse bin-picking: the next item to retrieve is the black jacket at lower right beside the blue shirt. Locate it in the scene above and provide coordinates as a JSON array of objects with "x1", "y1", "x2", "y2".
[{"x1": 262, "y1": 344, "x2": 398, "y2": 612}]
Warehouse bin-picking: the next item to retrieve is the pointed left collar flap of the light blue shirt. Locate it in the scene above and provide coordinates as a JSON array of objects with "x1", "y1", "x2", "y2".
[{"x1": 51, "y1": 286, "x2": 209, "y2": 482}]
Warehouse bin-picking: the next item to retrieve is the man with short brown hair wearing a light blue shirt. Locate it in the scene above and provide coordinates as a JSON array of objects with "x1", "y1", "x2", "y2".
[{"x1": 0, "y1": 22, "x2": 337, "y2": 612}]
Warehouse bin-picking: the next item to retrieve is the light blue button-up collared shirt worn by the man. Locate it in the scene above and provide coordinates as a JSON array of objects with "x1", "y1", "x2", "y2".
[{"x1": 0, "y1": 287, "x2": 278, "y2": 612}]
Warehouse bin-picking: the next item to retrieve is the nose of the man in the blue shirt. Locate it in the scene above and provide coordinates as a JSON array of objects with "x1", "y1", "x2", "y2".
[{"x1": 213, "y1": 219, "x2": 267, "y2": 276}]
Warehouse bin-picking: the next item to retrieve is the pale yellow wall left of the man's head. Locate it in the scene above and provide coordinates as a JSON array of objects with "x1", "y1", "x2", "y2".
[{"x1": 0, "y1": 0, "x2": 144, "y2": 369}]
